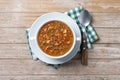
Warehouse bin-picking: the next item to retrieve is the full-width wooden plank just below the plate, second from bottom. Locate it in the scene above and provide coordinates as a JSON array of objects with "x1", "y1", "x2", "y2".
[{"x1": 0, "y1": 59, "x2": 120, "y2": 76}]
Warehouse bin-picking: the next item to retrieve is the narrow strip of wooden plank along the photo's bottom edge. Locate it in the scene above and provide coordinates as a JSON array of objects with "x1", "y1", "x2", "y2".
[{"x1": 0, "y1": 75, "x2": 120, "y2": 80}]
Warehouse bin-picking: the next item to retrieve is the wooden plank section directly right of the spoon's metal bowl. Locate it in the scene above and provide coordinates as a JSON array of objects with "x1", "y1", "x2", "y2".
[{"x1": 91, "y1": 13, "x2": 120, "y2": 28}]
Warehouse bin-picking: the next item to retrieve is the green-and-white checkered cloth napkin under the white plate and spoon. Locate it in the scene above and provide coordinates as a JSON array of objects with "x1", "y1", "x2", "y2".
[{"x1": 26, "y1": 6, "x2": 98, "y2": 68}]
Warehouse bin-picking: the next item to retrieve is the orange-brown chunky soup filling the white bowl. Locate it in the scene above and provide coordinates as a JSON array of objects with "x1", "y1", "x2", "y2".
[{"x1": 37, "y1": 21, "x2": 74, "y2": 56}]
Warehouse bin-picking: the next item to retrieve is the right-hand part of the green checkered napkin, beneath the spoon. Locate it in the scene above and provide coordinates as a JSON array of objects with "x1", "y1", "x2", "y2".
[{"x1": 65, "y1": 6, "x2": 98, "y2": 49}]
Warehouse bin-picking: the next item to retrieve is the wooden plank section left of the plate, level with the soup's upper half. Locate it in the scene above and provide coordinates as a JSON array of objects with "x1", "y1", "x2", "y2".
[{"x1": 0, "y1": 28, "x2": 27, "y2": 43}]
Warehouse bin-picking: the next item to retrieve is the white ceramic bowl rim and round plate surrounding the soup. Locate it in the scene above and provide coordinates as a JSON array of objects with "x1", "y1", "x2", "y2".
[{"x1": 29, "y1": 12, "x2": 81, "y2": 64}]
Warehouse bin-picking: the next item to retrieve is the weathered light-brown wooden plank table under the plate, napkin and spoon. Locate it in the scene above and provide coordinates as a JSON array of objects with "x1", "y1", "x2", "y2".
[{"x1": 0, "y1": 0, "x2": 120, "y2": 80}]
